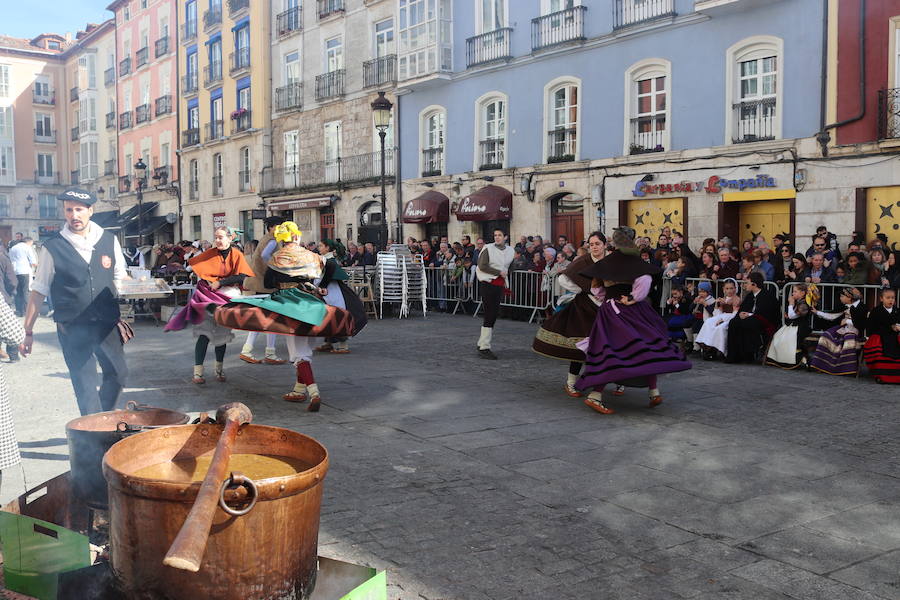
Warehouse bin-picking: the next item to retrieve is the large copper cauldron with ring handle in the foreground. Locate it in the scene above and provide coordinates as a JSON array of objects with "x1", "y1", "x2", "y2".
[{"x1": 103, "y1": 424, "x2": 328, "y2": 600}]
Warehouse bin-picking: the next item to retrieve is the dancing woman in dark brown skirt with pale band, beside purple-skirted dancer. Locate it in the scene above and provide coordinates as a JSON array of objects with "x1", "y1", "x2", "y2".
[{"x1": 531, "y1": 231, "x2": 625, "y2": 398}]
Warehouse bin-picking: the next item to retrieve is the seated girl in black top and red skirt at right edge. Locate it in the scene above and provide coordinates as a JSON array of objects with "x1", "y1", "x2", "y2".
[{"x1": 863, "y1": 290, "x2": 900, "y2": 383}]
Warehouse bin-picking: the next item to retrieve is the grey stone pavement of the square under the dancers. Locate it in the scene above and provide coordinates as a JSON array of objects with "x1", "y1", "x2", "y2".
[{"x1": 2, "y1": 315, "x2": 900, "y2": 600}]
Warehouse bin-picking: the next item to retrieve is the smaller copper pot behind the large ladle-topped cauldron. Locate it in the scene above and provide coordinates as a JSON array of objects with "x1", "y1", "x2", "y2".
[{"x1": 66, "y1": 402, "x2": 190, "y2": 510}]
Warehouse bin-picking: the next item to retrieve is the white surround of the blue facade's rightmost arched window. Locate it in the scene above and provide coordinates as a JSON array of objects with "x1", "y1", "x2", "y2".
[{"x1": 725, "y1": 35, "x2": 784, "y2": 145}]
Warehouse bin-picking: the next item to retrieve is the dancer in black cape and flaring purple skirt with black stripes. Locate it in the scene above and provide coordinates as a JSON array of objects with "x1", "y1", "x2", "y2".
[{"x1": 575, "y1": 227, "x2": 691, "y2": 414}]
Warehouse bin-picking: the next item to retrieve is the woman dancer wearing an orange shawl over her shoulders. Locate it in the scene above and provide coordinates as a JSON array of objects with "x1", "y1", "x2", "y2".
[{"x1": 165, "y1": 227, "x2": 253, "y2": 384}]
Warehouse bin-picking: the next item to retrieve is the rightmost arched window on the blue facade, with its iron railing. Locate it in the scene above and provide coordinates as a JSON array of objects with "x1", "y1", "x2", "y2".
[{"x1": 726, "y1": 36, "x2": 784, "y2": 144}]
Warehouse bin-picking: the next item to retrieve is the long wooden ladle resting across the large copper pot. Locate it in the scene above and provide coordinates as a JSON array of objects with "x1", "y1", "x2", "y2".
[{"x1": 163, "y1": 402, "x2": 253, "y2": 573}]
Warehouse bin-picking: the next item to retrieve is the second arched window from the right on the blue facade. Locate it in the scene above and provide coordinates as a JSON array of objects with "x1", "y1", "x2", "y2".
[{"x1": 624, "y1": 58, "x2": 672, "y2": 155}]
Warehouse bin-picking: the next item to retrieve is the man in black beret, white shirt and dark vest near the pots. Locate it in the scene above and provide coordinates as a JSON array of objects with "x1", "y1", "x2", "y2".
[{"x1": 20, "y1": 189, "x2": 128, "y2": 415}]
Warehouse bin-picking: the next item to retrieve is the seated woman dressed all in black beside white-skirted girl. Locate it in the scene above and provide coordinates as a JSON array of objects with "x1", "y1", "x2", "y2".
[{"x1": 725, "y1": 272, "x2": 779, "y2": 363}]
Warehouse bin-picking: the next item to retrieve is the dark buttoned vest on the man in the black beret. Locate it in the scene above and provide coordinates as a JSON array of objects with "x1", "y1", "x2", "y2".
[{"x1": 44, "y1": 231, "x2": 119, "y2": 323}]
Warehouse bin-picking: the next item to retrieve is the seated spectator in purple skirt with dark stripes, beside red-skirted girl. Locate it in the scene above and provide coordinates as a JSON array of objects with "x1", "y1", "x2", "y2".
[{"x1": 809, "y1": 287, "x2": 867, "y2": 375}]
